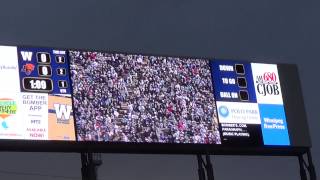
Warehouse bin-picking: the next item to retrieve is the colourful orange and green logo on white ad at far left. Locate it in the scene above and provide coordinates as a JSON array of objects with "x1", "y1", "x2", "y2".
[{"x1": 0, "y1": 98, "x2": 17, "y2": 129}]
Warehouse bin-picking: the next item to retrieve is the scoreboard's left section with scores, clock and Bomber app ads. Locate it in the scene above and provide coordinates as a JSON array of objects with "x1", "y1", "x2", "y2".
[{"x1": 0, "y1": 46, "x2": 75, "y2": 140}]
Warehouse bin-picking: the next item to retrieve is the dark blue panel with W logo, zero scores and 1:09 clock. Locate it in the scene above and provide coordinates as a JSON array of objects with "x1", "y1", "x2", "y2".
[{"x1": 18, "y1": 47, "x2": 71, "y2": 96}]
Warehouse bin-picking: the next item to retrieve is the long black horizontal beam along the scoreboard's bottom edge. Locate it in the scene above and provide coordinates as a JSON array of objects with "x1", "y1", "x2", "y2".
[{"x1": 0, "y1": 140, "x2": 310, "y2": 156}]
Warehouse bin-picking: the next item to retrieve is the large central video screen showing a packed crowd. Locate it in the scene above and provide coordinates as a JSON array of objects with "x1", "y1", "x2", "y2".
[{"x1": 69, "y1": 51, "x2": 221, "y2": 144}]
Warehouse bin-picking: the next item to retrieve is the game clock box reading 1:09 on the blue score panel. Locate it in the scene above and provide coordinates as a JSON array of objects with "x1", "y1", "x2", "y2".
[{"x1": 23, "y1": 77, "x2": 53, "y2": 92}]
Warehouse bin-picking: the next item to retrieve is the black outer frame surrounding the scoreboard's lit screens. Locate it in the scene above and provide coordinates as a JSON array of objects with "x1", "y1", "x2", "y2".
[{"x1": 0, "y1": 44, "x2": 312, "y2": 156}]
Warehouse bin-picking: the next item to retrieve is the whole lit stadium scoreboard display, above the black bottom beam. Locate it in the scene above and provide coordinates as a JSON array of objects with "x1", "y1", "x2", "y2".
[{"x1": 0, "y1": 46, "x2": 310, "y2": 153}]
